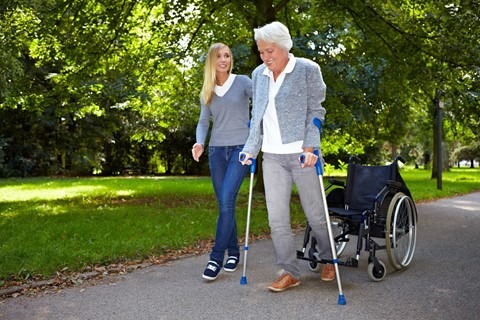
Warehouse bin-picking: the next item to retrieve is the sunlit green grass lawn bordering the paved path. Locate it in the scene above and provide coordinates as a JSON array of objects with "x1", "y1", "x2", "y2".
[{"x1": 0, "y1": 168, "x2": 480, "y2": 286}]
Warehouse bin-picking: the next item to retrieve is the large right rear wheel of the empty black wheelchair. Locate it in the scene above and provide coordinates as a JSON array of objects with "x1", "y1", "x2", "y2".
[{"x1": 385, "y1": 192, "x2": 417, "y2": 270}]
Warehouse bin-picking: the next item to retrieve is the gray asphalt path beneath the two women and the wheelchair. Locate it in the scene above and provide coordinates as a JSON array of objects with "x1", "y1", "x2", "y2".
[{"x1": 0, "y1": 193, "x2": 480, "y2": 320}]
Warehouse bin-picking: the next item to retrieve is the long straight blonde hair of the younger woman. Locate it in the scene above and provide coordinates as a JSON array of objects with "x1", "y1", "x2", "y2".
[{"x1": 200, "y1": 43, "x2": 233, "y2": 106}]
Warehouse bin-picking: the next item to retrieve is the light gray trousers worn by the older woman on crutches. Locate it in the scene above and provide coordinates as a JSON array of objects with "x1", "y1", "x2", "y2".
[{"x1": 262, "y1": 153, "x2": 332, "y2": 278}]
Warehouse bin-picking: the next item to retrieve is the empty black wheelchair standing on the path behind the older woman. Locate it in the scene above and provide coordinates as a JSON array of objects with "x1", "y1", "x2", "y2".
[{"x1": 297, "y1": 156, "x2": 418, "y2": 281}]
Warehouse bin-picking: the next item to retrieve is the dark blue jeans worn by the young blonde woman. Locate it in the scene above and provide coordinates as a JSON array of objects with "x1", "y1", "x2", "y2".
[{"x1": 208, "y1": 145, "x2": 248, "y2": 266}]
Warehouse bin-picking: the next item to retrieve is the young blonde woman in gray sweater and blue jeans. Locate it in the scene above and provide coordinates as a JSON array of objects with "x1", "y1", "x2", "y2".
[{"x1": 192, "y1": 43, "x2": 252, "y2": 280}]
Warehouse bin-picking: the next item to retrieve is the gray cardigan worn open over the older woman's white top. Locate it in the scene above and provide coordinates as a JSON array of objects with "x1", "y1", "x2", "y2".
[{"x1": 243, "y1": 58, "x2": 326, "y2": 157}]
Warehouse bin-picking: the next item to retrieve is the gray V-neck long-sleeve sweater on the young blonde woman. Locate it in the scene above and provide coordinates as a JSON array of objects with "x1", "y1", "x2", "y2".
[{"x1": 196, "y1": 75, "x2": 252, "y2": 147}]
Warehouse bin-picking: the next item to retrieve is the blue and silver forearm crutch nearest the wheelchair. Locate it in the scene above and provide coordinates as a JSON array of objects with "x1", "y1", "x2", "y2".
[{"x1": 313, "y1": 118, "x2": 347, "y2": 305}]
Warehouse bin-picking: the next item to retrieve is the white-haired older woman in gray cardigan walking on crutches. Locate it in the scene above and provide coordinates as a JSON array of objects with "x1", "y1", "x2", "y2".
[{"x1": 241, "y1": 22, "x2": 335, "y2": 292}]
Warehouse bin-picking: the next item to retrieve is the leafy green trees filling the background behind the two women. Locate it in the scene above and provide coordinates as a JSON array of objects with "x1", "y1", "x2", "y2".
[{"x1": 0, "y1": 0, "x2": 480, "y2": 176}]
